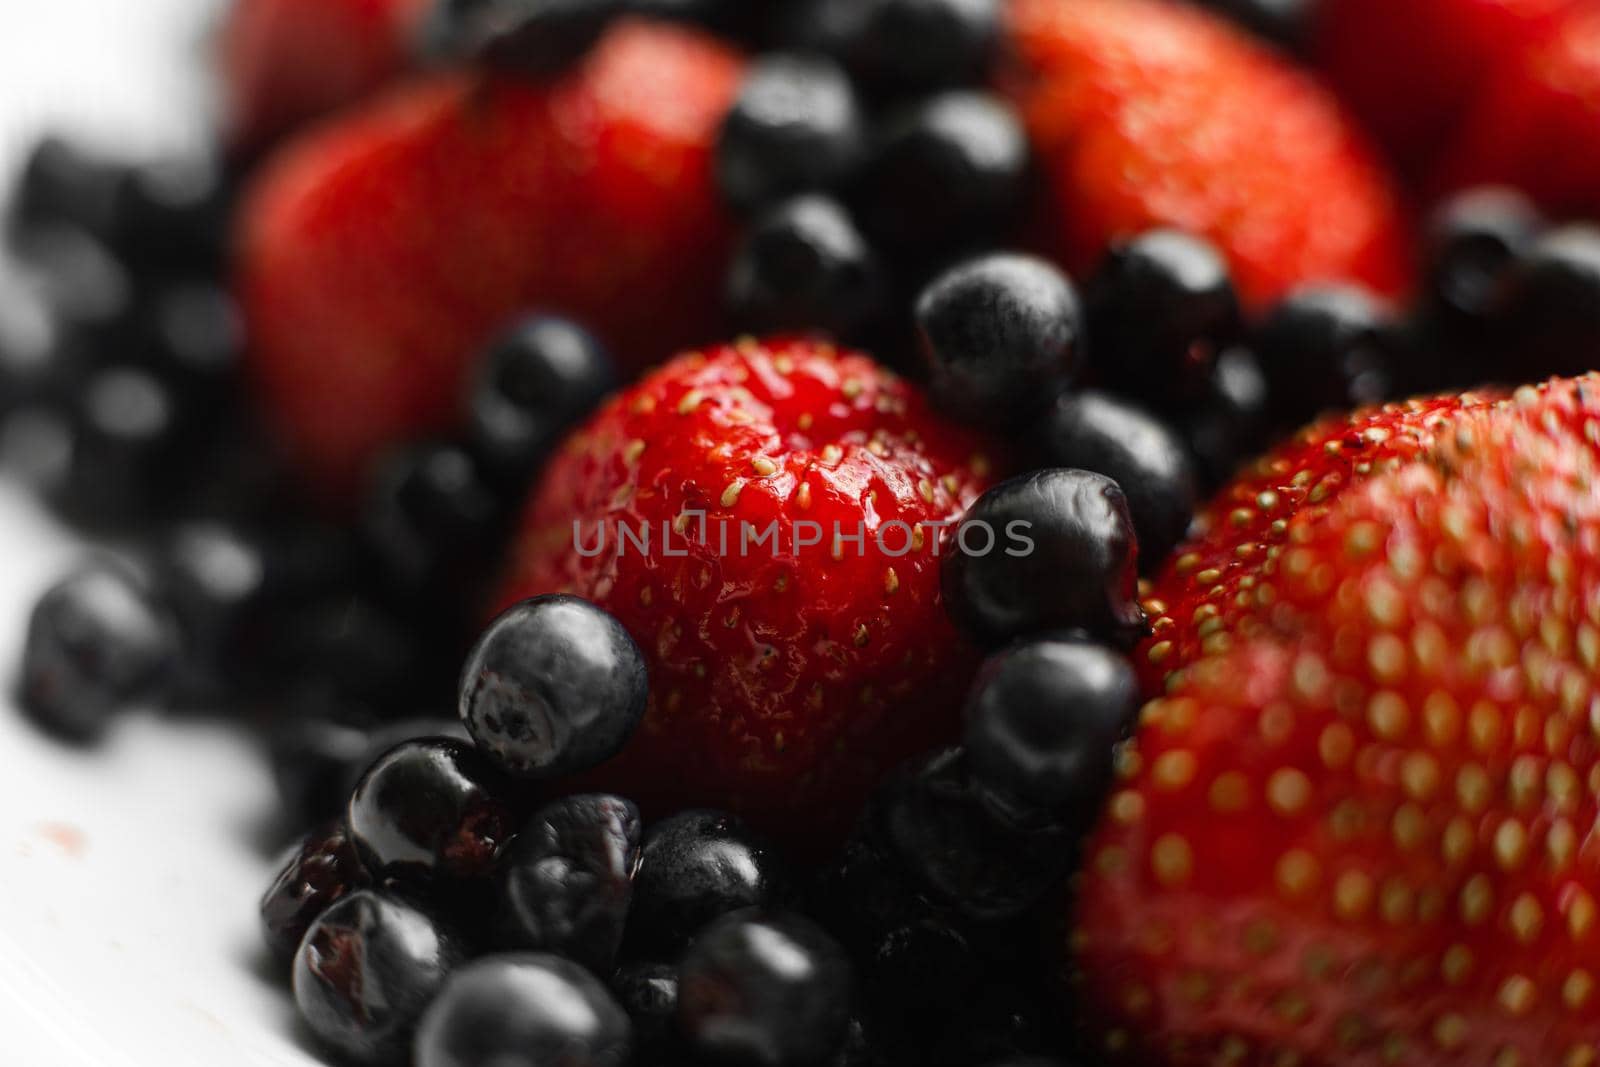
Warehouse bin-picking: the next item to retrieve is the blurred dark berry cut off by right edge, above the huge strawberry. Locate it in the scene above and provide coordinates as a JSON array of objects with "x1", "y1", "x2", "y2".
[{"x1": 1498, "y1": 224, "x2": 1600, "y2": 382}]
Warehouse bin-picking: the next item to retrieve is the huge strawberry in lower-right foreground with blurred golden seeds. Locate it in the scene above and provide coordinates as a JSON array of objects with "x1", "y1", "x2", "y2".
[{"x1": 1072, "y1": 376, "x2": 1600, "y2": 1067}]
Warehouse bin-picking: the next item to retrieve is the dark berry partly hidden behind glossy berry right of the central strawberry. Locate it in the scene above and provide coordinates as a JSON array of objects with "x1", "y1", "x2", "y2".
[{"x1": 1038, "y1": 390, "x2": 1198, "y2": 569}]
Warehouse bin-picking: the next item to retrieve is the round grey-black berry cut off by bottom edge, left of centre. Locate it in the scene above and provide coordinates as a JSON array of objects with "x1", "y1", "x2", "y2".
[{"x1": 414, "y1": 953, "x2": 632, "y2": 1067}]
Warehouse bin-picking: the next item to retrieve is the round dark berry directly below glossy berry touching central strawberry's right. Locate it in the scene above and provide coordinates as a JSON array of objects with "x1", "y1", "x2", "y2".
[{"x1": 963, "y1": 637, "x2": 1139, "y2": 825}]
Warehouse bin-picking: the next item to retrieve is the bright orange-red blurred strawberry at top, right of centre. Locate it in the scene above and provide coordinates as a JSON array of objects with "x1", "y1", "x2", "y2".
[{"x1": 1011, "y1": 0, "x2": 1406, "y2": 307}]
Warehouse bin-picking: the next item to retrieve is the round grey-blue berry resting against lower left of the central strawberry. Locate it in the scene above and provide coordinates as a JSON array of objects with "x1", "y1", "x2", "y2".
[{"x1": 458, "y1": 595, "x2": 650, "y2": 779}]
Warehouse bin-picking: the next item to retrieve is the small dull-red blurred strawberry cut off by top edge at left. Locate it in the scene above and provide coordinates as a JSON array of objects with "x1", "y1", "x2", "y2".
[{"x1": 221, "y1": 0, "x2": 432, "y2": 152}]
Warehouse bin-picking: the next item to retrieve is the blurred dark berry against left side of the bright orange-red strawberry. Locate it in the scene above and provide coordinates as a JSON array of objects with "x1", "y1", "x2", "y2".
[{"x1": 854, "y1": 91, "x2": 1029, "y2": 258}]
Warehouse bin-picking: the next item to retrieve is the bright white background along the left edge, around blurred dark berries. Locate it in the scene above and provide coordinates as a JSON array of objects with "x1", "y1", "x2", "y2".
[{"x1": 0, "y1": 0, "x2": 326, "y2": 1067}]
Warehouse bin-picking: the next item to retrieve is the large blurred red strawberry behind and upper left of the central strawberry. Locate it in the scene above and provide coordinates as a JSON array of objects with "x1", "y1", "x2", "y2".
[{"x1": 240, "y1": 22, "x2": 741, "y2": 490}]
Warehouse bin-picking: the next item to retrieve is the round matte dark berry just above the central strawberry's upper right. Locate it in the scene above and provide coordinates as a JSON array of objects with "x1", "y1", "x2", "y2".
[{"x1": 915, "y1": 254, "x2": 1083, "y2": 426}]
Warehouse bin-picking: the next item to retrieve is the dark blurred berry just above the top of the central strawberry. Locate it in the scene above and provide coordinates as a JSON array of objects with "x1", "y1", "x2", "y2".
[{"x1": 728, "y1": 195, "x2": 885, "y2": 339}]
